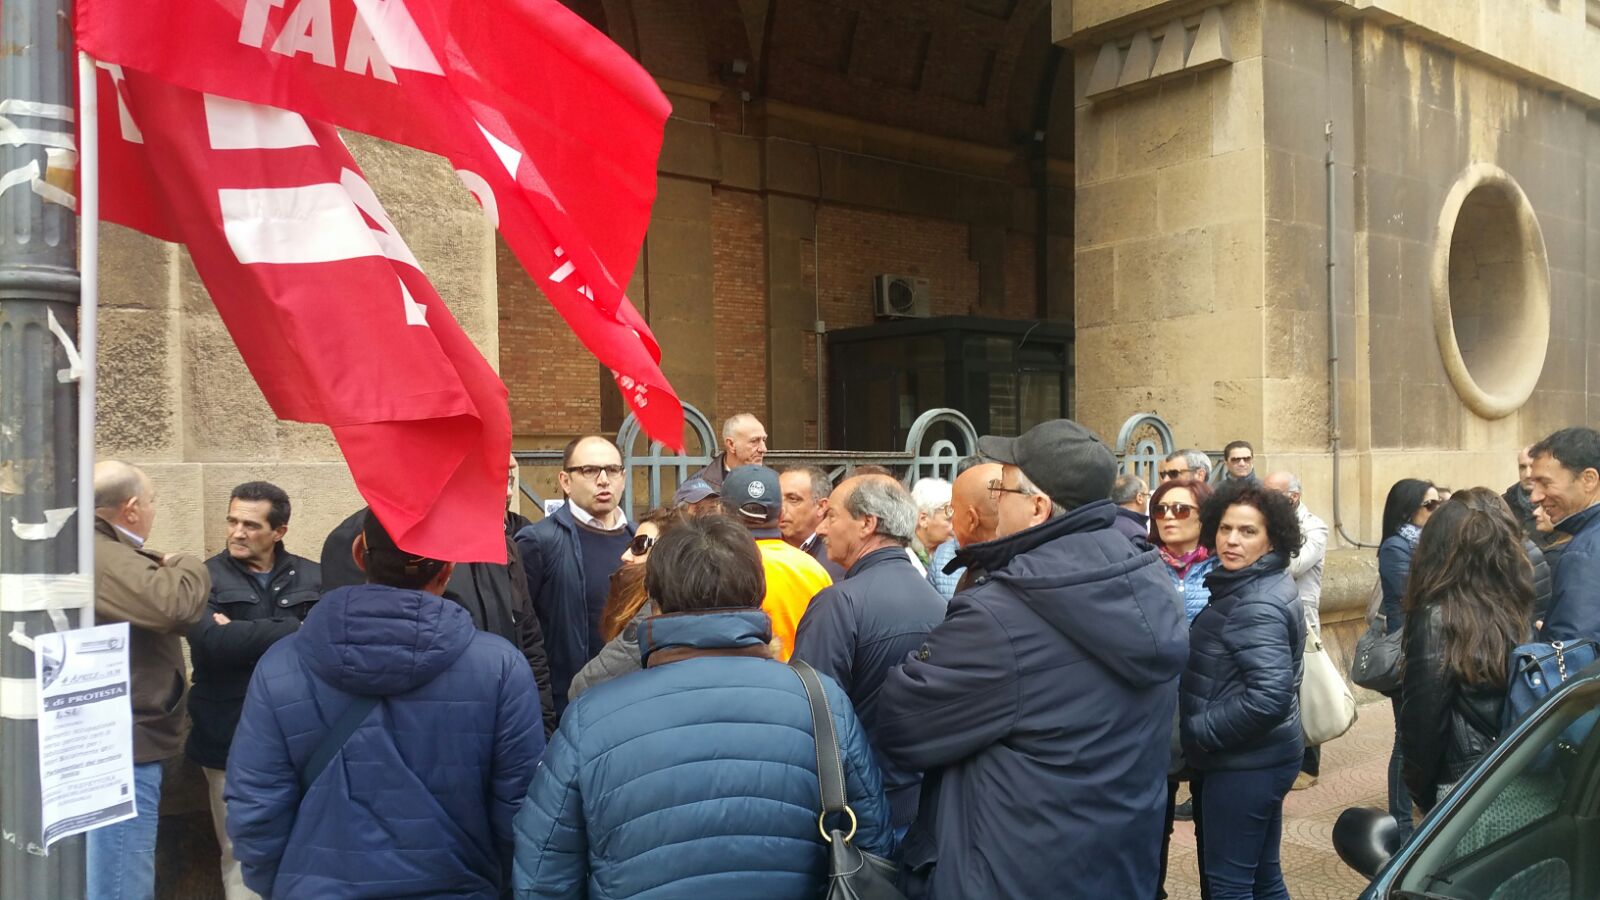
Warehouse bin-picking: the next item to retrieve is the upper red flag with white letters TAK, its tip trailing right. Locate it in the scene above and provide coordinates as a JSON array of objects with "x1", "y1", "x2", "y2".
[{"x1": 77, "y1": 0, "x2": 683, "y2": 447}]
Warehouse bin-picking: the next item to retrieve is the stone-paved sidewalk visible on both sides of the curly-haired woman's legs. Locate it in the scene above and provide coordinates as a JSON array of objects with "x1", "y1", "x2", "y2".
[{"x1": 1166, "y1": 701, "x2": 1394, "y2": 900}]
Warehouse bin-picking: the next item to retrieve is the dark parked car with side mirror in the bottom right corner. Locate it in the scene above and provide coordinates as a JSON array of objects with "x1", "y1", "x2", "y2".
[{"x1": 1333, "y1": 665, "x2": 1600, "y2": 900}]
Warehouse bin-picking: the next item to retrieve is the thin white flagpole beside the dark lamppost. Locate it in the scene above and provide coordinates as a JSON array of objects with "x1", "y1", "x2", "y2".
[{"x1": 77, "y1": 50, "x2": 99, "y2": 608}]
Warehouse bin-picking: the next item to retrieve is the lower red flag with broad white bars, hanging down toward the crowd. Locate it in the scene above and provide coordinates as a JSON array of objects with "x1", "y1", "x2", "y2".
[{"x1": 99, "y1": 72, "x2": 510, "y2": 562}]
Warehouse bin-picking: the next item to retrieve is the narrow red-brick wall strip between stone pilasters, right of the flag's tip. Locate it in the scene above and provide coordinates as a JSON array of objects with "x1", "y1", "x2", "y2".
[{"x1": 713, "y1": 189, "x2": 768, "y2": 426}]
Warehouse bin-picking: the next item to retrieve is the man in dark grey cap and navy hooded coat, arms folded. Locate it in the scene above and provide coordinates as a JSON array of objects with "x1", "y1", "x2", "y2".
[{"x1": 874, "y1": 420, "x2": 1189, "y2": 900}]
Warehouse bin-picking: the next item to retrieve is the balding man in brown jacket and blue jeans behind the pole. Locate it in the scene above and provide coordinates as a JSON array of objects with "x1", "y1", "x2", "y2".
[{"x1": 88, "y1": 460, "x2": 211, "y2": 900}]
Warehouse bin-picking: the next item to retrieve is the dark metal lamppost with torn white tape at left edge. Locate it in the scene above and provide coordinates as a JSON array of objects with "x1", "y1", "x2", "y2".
[{"x1": 0, "y1": 0, "x2": 93, "y2": 900}]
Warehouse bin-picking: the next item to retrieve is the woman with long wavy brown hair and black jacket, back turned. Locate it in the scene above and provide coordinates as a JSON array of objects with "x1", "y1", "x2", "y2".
[{"x1": 1395, "y1": 488, "x2": 1533, "y2": 814}]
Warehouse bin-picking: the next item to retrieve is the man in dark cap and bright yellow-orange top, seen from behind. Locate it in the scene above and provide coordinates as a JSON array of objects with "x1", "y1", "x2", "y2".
[{"x1": 722, "y1": 466, "x2": 834, "y2": 661}]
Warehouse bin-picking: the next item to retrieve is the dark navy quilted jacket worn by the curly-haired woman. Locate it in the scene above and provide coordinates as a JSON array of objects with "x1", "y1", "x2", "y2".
[{"x1": 1179, "y1": 552, "x2": 1306, "y2": 770}]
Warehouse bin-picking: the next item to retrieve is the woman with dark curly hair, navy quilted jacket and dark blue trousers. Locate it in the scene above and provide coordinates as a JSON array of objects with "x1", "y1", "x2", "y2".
[{"x1": 1179, "y1": 482, "x2": 1306, "y2": 900}]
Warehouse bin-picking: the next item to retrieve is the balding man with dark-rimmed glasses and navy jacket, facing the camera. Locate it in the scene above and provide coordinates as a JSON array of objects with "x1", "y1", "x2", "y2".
[{"x1": 517, "y1": 434, "x2": 634, "y2": 717}]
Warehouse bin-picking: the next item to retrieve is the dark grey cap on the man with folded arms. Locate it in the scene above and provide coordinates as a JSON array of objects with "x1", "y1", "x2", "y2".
[{"x1": 978, "y1": 418, "x2": 1117, "y2": 509}]
